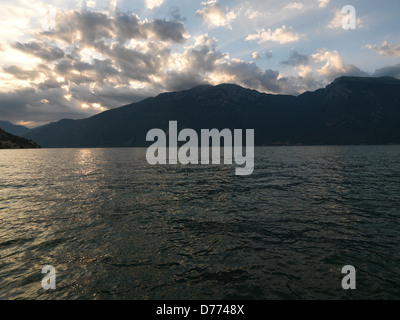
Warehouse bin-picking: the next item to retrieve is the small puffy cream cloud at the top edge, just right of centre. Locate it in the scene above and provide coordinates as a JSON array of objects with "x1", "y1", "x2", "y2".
[{"x1": 196, "y1": 0, "x2": 236, "y2": 29}]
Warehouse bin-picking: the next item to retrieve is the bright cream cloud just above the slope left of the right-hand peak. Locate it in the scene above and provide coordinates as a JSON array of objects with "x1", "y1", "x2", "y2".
[{"x1": 312, "y1": 49, "x2": 367, "y2": 81}]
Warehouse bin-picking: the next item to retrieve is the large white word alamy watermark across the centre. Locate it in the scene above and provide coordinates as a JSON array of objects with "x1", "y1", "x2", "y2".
[{"x1": 146, "y1": 121, "x2": 254, "y2": 176}]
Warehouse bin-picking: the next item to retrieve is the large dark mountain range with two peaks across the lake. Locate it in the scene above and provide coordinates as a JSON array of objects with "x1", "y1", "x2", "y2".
[{"x1": 25, "y1": 77, "x2": 400, "y2": 147}]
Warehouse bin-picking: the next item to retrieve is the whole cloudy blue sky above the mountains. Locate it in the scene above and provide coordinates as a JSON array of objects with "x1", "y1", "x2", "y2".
[{"x1": 0, "y1": 0, "x2": 400, "y2": 127}]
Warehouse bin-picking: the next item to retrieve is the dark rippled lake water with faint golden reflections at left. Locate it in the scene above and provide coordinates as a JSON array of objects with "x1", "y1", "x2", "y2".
[{"x1": 0, "y1": 146, "x2": 400, "y2": 299}]
